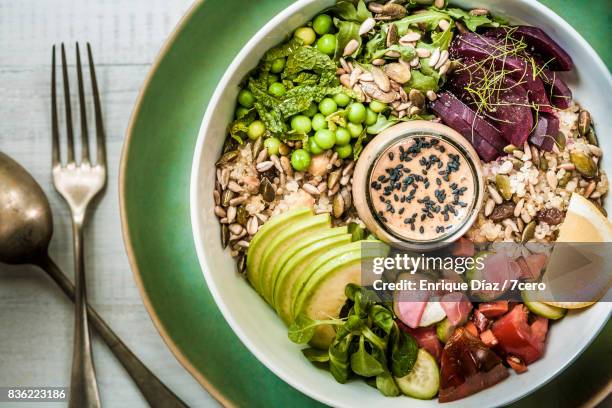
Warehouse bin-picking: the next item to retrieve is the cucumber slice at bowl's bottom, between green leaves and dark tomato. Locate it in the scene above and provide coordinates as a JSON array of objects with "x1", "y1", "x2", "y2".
[{"x1": 395, "y1": 349, "x2": 440, "y2": 399}]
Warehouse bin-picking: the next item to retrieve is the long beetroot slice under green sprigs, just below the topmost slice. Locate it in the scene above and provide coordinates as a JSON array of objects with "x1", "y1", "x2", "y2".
[{"x1": 450, "y1": 33, "x2": 551, "y2": 112}]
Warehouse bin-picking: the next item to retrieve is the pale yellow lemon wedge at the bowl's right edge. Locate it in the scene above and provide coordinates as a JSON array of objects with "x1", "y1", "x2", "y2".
[{"x1": 543, "y1": 193, "x2": 612, "y2": 309}]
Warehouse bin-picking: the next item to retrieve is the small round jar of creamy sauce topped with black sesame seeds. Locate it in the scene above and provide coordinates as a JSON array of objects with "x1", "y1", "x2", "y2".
[{"x1": 353, "y1": 121, "x2": 484, "y2": 251}]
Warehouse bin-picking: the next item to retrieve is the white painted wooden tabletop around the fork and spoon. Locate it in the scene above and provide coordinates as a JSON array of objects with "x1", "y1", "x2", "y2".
[{"x1": 0, "y1": 0, "x2": 218, "y2": 408}]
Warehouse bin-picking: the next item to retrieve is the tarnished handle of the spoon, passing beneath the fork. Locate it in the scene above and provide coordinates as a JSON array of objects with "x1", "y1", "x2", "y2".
[{"x1": 37, "y1": 256, "x2": 187, "y2": 408}]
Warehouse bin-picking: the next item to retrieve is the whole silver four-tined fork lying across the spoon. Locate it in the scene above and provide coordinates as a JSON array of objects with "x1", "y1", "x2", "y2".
[{"x1": 51, "y1": 43, "x2": 106, "y2": 408}]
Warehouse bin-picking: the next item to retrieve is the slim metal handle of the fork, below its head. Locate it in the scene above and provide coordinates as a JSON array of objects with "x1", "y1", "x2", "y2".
[{"x1": 68, "y1": 217, "x2": 101, "y2": 408}]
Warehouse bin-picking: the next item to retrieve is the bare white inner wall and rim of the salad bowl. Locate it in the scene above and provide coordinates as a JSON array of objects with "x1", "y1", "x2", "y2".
[{"x1": 191, "y1": 0, "x2": 612, "y2": 407}]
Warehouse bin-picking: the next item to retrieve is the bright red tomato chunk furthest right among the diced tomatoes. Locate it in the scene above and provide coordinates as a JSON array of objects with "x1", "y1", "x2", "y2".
[{"x1": 491, "y1": 304, "x2": 548, "y2": 364}]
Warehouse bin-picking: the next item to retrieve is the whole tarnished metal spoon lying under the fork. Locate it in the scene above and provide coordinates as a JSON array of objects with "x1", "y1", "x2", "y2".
[{"x1": 0, "y1": 152, "x2": 187, "y2": 407}]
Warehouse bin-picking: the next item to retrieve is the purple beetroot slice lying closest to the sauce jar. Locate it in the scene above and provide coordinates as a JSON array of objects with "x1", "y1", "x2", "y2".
[{"x1": 431, "y1": 92, "x2": 506, "y2": 162}]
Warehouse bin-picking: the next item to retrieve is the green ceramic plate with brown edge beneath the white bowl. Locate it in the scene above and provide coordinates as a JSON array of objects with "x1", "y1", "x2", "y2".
[{"x1": 120, "y1": 0, "x2": 610, "y2": 406}]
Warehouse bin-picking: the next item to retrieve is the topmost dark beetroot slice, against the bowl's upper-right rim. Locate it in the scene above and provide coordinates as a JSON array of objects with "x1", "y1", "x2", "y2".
[{"x1": 485, "y1": 26, "x2": 574, "y2": 71}]
